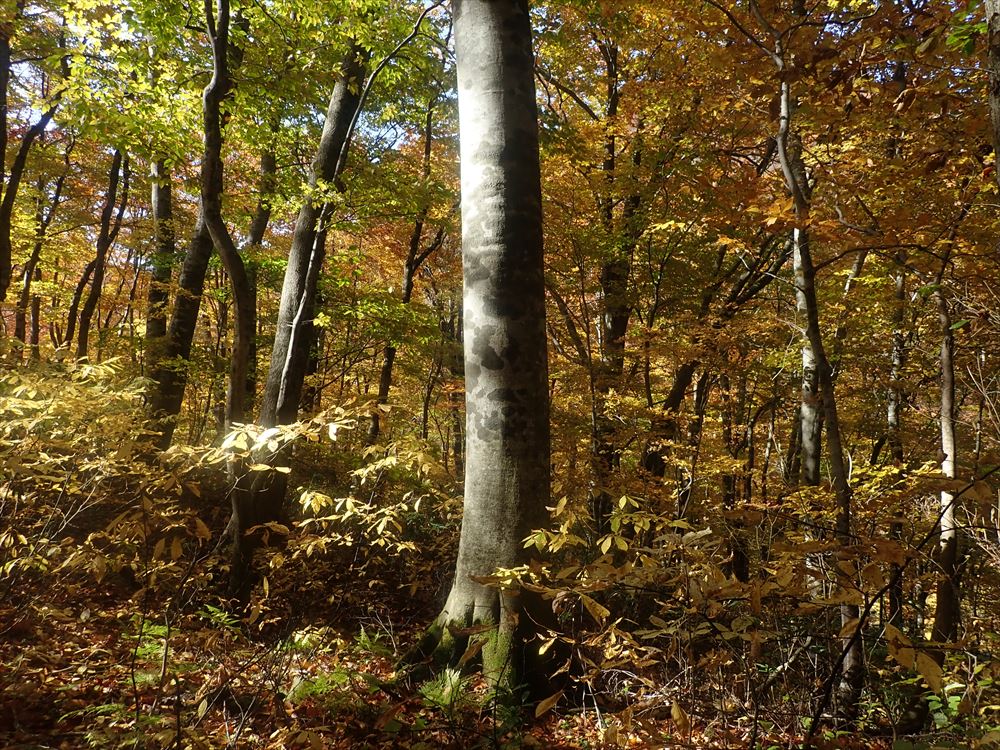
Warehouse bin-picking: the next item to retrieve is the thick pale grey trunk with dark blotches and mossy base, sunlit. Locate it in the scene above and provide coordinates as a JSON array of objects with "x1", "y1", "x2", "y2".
[{"x1": 425, "y1": 0, "x2": 549, "y2": 687}]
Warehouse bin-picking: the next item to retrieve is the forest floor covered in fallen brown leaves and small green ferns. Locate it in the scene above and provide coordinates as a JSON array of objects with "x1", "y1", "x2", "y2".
[{"x1": 0, "y1": 548, "x2": 900, "y2": 749}]
